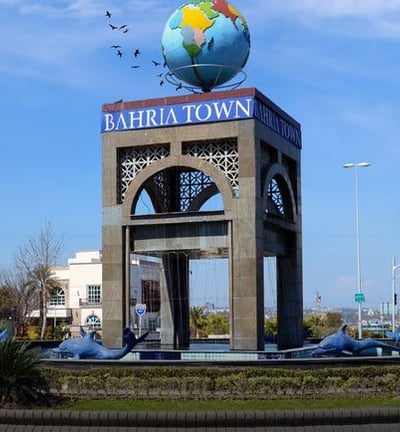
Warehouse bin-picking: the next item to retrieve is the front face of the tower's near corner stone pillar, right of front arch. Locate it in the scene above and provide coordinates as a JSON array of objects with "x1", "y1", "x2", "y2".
[{"x1": 230, "y1": 127, "x2": 264, "y2": 350}]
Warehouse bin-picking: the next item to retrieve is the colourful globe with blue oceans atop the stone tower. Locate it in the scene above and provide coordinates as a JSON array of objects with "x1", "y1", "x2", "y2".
[{"x1": 161, "y1": 0, "x2": 250, "y2": 92}]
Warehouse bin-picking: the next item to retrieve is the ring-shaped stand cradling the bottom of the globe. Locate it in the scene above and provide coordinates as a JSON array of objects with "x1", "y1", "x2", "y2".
[{"x1": 165, "y1": 63, "x2": 247, "y2": 93}]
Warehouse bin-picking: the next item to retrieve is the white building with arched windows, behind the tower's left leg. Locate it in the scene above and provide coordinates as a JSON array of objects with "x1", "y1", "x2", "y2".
[{"x1": 49, "y1": 251, "x2": 160, "y2": 337}]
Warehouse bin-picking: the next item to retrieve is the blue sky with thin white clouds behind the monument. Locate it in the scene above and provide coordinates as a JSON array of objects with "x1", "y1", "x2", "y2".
[{"x1": 0, "y1": 0, "x2": 400, "y2": 308}]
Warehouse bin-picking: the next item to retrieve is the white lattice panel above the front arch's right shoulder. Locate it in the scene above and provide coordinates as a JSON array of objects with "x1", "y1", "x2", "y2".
[{"x1": 183, "y1": 138, "x2": 239, "y2": 190}]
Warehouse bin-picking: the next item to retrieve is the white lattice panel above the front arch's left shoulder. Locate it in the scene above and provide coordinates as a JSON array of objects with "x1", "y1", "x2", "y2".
[{"x1": 117, "y1": 144, "x2": 169, "y2": 203}]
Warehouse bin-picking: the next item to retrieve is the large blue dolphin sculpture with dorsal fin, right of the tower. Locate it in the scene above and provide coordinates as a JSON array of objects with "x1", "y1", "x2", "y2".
[{"x1": 311, "y1": 324, "x2": 400, "y2": 357}]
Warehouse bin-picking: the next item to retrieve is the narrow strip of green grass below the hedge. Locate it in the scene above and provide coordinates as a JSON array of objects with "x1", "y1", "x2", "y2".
[{"x1": 58, "y1": 398, "x2": 400, "y2": 412}]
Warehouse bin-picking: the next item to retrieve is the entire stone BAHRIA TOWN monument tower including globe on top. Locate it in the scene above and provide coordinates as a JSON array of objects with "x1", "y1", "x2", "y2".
[{"x1": 102, "y1": 0, "x2": 303, "y2": 350}]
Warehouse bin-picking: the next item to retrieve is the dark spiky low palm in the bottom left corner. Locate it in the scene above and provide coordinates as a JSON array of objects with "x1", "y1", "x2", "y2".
[{"x1": 0, "y1": 338, "x2": 49, "y2": 407}]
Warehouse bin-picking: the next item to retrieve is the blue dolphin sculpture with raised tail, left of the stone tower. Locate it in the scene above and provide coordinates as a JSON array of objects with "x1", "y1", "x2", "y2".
[{"x1": 51, "y1": 327, "x2": 149, "y2": 360}]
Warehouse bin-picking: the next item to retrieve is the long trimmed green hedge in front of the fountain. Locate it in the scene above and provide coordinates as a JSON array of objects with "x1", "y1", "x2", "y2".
[{"x1": 44, "y1": 366, "x2": 400, "y2": 400}]
